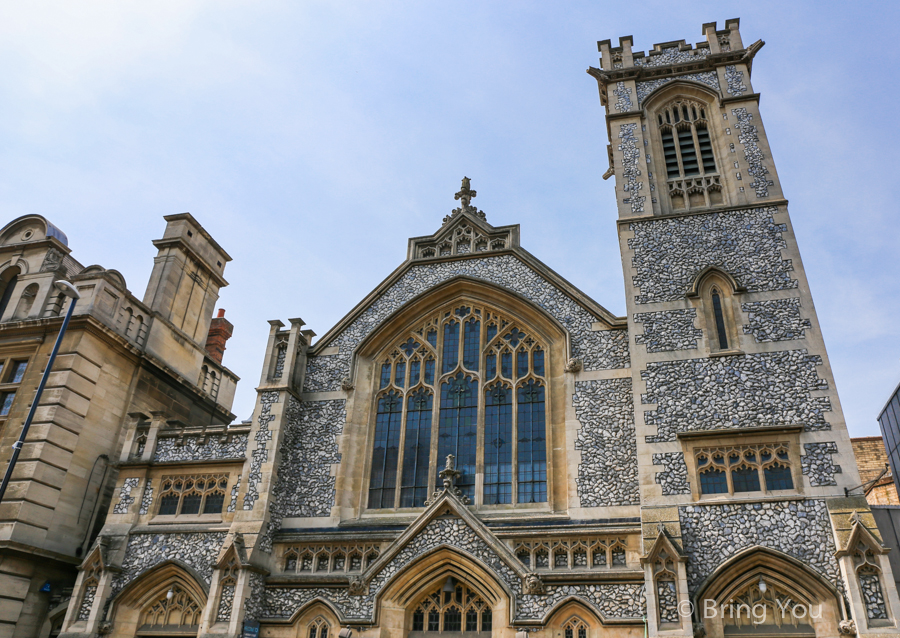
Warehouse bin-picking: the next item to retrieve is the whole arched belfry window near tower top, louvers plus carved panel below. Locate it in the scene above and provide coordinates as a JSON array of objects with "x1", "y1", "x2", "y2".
[{"x1": 656, "y1": 98, "x2": 724, "y2": 209}]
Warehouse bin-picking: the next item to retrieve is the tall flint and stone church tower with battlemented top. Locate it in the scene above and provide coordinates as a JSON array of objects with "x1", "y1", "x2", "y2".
[{"x1": 588, "y1": 20, "x2": 900, "y2": 635}]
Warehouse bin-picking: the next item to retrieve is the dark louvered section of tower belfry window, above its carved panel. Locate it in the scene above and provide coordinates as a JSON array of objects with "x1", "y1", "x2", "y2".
[{"x1": 657, "y1": 100, "x2": 716, "y2": 179}]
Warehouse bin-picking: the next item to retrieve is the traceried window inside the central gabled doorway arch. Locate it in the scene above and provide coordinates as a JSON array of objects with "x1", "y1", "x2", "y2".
[{"x1": 412, "y1": 579, "x2": 493, "y2": 633}]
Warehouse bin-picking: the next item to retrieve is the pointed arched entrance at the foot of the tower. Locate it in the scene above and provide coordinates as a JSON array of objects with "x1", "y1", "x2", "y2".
[{"x1": 695, "y1": 548, "x2": 841, "y2": 638}]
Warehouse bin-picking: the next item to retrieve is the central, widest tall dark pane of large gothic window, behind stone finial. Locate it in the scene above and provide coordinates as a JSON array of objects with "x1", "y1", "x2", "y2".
[{"x1": 437, "y1": 372, "x2": 478, "y2": 500}]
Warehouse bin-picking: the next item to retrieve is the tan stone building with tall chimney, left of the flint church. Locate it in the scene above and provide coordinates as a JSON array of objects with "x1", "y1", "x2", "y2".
[{"x1": 0, "y1": 214, "x2": 239, "y2": 637}]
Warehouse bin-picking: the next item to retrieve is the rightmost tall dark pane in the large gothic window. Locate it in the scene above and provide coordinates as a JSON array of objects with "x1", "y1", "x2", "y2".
[{"x1": 516, "y1": 381, "x2": 547, "y2": 503}]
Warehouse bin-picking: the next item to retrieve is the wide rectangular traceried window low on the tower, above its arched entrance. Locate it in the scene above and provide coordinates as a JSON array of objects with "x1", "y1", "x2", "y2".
[{"x1": 694, "y1": 443, "x2": 794, "y2": 494}]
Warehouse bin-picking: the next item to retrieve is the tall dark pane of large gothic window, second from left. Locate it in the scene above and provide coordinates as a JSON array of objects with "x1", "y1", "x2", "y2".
[{"x1": 400, "y1": 390, "x2": 433, "y2": 507}]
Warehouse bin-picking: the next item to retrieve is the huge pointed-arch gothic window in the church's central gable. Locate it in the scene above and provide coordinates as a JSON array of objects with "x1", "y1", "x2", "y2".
[{"x1": 368, "y1": 302, "x2": 547, "y2": 509}]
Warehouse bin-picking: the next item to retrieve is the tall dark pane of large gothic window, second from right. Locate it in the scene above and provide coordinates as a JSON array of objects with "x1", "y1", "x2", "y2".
[{"x1": 484, "y1": 385, "x2": 512, "y2": 505}]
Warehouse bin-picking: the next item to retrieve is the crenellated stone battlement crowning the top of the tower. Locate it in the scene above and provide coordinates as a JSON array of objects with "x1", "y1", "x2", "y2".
[{"x1": 597, "y1": 18, "x2": 744, "y2": 71}]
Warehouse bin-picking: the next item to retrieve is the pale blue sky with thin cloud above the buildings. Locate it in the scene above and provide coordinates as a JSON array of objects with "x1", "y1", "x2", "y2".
[{"x1": 0, "y1": 0, "x2": 900, "y2": 436}]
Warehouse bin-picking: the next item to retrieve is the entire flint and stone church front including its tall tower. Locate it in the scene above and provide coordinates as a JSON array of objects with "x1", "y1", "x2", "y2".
[{"x1": 62, "y1": 20, "x2": 900, "y2": 638}]
